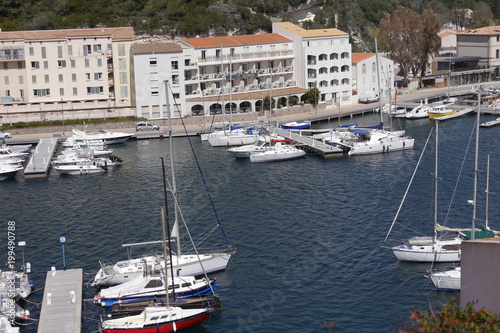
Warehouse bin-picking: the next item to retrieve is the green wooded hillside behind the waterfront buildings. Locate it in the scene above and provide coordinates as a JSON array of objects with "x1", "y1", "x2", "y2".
[{"x1": 0, "y1": 0, "x2": 500, "y2": 51}]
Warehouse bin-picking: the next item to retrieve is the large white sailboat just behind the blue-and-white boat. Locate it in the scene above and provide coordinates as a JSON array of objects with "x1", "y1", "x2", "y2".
[{"x1": 92, "y1": 81, "x2": 234, "y2": 287}]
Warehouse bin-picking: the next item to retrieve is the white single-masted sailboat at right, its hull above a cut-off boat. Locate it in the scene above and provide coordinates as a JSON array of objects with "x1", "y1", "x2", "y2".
[{"x1": 385, "y1": 120, "x2": 462, "y2": 262}]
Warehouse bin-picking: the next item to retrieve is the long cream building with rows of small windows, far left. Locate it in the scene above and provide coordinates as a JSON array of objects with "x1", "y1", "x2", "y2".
[{"x1": 0, "y1": 28, "x2": 133, "y2": 122}]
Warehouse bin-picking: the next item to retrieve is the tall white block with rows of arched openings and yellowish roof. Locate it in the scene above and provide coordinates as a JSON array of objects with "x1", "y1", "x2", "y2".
[{"x1": 273, "y1": 22, "x2": 352, "y2": 105}]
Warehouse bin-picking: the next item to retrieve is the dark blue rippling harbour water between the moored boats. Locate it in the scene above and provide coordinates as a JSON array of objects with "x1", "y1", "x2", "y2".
[{"x1": 0, "y1": 114, "x2": 500, "y2": 333}]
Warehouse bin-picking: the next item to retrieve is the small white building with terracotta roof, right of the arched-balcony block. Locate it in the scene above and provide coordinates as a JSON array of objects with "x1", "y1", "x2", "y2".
[{"x1": 351, "y1": 53, "x2": 397, "y2": 98}]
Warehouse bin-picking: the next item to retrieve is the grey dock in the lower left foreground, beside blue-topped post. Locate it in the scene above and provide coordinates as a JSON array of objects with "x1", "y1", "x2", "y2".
[{"x1": 37, "y1": 268, "x2": 83, "y2": 333}]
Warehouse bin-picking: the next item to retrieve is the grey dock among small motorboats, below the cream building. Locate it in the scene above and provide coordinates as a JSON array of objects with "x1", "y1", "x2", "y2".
[{"x1": 24, "y1": 138, "x2": 58, "y2": 178}]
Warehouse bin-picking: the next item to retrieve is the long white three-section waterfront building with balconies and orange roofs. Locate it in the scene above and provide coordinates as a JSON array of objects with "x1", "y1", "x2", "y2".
[{"x1": 132, "y1": 23, "x2": 352, "y2": 118}]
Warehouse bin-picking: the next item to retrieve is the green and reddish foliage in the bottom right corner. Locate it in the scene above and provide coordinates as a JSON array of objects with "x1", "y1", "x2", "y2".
[{"x1": 399, "y1": 300, "x2": 500, "y2": 333}]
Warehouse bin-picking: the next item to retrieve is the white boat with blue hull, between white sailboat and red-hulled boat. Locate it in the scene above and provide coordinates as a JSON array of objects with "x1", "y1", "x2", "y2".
[{"x1": 94, "y1": 274, "x2": 215, "y2": 306}]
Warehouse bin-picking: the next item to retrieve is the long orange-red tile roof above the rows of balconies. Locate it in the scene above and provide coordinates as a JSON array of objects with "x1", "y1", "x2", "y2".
[{"x1": 181, "y1": 34, "x2": 291, "y2": 49}]
